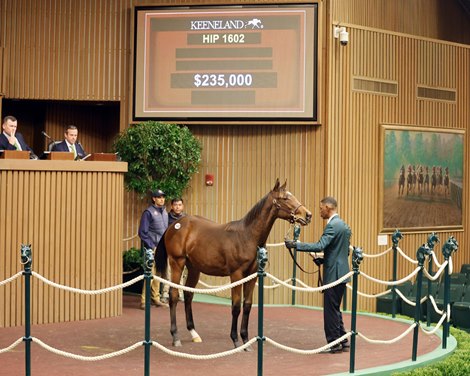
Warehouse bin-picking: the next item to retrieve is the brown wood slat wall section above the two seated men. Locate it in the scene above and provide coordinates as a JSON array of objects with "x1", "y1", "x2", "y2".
[{"x1": 0, "y1": 0, "x2": 131, "y2": 100}]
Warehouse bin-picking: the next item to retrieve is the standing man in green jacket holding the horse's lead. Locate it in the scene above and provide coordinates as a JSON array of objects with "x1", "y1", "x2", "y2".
[{"x1": 286, "y1": 197, "x2": 351, "y2": 353}]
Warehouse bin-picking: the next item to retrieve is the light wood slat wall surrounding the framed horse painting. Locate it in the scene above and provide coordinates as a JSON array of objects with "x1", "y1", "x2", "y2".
[{"x1": 326, "y1": 24, "x2": 470, "y2": 311}]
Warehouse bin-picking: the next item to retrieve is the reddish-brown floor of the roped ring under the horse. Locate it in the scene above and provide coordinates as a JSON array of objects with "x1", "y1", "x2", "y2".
[{"x1": 0, "y1": 295, "x2": 441, "y2": 376}]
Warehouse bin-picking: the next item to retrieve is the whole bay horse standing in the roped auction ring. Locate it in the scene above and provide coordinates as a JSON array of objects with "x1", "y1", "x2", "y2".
[{"x1": 156, "y1": 179, "x2": 312, "y2": 347}]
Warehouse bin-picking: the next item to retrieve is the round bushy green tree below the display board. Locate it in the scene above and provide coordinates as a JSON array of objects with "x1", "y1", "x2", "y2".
[{"x1": 113, "y1": 121, "x2": 202, "y2": 198}]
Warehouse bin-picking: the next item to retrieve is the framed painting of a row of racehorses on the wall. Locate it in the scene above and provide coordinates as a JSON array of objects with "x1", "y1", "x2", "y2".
[{"x1": 379, "y1": 125, "x2": 465, "y2": 232}]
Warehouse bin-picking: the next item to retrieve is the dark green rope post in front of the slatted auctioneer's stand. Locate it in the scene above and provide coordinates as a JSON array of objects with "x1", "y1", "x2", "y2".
[{"x1": 21, "y1": 244, "x2": 33, "y2": 376}]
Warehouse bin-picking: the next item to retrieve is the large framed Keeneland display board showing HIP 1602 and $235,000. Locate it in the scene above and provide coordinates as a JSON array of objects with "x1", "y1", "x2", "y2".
[{"x1": 133, "y1": 4, "x2": 317, "y2": 121}]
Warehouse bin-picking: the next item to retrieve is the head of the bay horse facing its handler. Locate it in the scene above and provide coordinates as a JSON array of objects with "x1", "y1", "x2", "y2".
[{"x1": 271, "y1": 179, "x2": 312, "y2": 226}]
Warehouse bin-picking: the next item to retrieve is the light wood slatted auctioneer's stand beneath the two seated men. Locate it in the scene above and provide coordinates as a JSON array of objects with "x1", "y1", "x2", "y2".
[{"x1": 0, "y1": 154, "x2": 127, "y2": 328}]
